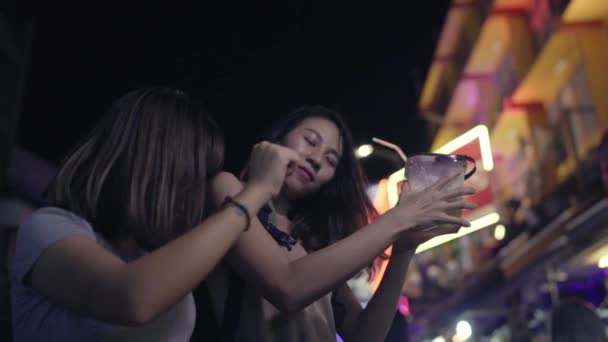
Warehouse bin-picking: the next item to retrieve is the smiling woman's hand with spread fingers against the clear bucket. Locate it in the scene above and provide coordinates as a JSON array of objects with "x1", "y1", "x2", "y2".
[{"x1": 389, "y1": 174, "x2": 475, "y2": 233}]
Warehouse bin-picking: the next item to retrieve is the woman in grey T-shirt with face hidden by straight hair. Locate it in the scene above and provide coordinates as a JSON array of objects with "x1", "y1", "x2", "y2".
[{"x1": 11, "y1": 87, "x2": 299, "y2": 342}]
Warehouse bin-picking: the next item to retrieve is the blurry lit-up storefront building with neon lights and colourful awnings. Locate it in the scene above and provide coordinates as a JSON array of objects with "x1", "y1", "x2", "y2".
[{"x1": 370, "y1": 0, "x2": 608, "y2": 341}]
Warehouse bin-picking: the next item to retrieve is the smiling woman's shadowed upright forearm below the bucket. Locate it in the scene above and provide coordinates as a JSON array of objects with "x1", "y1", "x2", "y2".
[{"x1": 348, "y1": 249, "x2": 415, "y2": 342}]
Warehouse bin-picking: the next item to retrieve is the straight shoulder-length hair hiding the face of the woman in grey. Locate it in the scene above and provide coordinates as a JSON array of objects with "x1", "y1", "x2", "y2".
[{"x1": 48, "y1": 87, "x2": 224, "y2": 250}]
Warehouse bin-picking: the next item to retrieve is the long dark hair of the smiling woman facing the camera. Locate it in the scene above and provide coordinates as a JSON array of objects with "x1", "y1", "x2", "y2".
[{"x1": 254, "y1": 106, "x2": 378, "y2": 272}]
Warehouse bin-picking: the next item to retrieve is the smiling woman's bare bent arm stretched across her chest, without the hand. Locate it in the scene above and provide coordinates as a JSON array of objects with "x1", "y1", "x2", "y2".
[{"x1": 215, "y1": 175, "x2": 408, "y2": 311}]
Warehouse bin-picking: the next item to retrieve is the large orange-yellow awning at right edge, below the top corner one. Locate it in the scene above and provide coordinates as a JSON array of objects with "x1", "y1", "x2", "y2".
[{"x1": 510, "y1": 21, "x2": 608, "y2": 178}]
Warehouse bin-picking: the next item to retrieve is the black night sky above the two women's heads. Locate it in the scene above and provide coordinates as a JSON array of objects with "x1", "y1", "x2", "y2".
[{"x1": 17, "y1": 0, "x2": 448, "y2": 179}]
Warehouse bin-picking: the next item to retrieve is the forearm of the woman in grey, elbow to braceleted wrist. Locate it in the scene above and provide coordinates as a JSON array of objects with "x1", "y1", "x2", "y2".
[{"x1": 125, "y1": 187, "x2": 264, "y2": 321}]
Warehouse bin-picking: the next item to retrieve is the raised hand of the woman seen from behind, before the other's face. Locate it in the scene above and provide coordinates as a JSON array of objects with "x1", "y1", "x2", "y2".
[{"x1": 247, "y1": 141, "x2": 306, "y2": 200}]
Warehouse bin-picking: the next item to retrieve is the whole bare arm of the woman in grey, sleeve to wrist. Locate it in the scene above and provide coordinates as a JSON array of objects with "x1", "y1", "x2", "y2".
[{"x1": 30, "y1": 188, "x2": 262, "y2": 325}]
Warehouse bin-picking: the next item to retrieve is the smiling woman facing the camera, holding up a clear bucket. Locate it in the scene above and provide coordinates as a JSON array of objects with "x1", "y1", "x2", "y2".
[{"x1": 204, "y1": 107, "x2": 474, "y2": 342}]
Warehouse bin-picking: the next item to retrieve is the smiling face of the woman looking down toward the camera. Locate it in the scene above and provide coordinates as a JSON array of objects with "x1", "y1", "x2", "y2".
[{"x1": 283, "y1": 117, "x2": 342, "y2": 199}]
